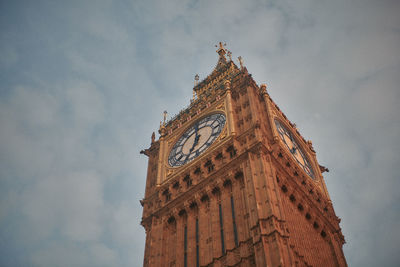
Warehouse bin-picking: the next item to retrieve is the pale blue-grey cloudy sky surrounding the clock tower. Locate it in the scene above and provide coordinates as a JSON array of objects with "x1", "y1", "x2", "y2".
[{"x1": 0, "y1": 0, "x2": 400, "y2": 266}]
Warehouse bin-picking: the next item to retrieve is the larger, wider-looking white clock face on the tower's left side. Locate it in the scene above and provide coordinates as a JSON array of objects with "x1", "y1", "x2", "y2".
[{"x1": 168, "y1": 113, "x2": 225, "y2": 167}]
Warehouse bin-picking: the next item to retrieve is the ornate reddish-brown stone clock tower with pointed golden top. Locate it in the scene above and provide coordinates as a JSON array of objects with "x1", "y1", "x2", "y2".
[{"x1": 141, "y1": 43, "x2": 347, "y2": 267}]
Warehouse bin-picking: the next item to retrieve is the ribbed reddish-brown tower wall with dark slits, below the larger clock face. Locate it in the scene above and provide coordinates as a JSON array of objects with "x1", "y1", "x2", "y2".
[{"x1": 144, "y1": 168, "x2": 263, "y2": 266}]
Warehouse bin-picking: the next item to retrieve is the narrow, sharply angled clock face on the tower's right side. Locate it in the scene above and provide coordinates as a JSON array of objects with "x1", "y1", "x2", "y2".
[{"x1": 275, "y1": 120, "x2": 314, "y2": 179}]
